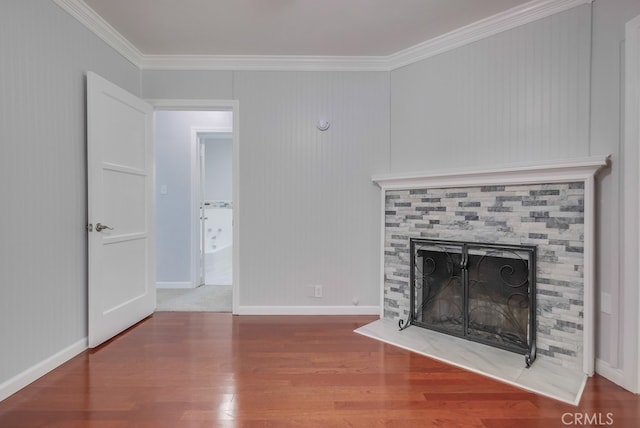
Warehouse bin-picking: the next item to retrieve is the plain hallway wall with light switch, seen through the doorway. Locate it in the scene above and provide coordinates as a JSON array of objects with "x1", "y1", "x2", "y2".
[{"x1": 155, "y1": 111, "x2": 231, "y2": 286}]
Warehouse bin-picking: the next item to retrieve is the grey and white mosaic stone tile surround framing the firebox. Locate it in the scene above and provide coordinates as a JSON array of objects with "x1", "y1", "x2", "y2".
[{"x1": 383, "y1": 181, "x2": 585, "y2": 370}]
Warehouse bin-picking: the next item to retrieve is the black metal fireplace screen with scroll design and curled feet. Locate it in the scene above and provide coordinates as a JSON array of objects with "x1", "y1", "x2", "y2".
[{"x1": 399, "y1": 238, "x2": 536, "y2": 367}]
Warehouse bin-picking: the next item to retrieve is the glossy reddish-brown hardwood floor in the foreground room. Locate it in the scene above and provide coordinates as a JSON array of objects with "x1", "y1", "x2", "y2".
[{"x1": 0, "y1": 312, "x2": 640, "y2": 428}]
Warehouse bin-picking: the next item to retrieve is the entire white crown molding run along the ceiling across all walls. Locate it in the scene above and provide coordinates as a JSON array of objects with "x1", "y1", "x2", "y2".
[{"x1": 53, "y1": 0, "x2": 593, "y2": 71}]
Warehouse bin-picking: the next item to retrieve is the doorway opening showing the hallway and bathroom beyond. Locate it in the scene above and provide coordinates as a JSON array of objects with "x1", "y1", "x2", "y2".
[{"x1": 152, "y1": 100, "x2": 239, "y2": 312}]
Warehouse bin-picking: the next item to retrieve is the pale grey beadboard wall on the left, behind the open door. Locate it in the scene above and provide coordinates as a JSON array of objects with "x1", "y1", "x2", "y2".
[{"x1": 0, "y1": 0, "x2": 140, "y2": 398}]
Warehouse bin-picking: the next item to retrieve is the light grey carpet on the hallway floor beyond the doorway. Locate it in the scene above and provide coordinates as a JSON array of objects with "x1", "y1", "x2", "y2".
[{"x1": 156, "y1": 285, "x2": 231, "y2": 312}]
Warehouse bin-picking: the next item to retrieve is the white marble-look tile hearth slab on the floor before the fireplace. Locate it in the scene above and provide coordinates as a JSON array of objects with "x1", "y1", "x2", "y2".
[{"x1": 355, "y1": 318, "x2": 587, "y2": 406}]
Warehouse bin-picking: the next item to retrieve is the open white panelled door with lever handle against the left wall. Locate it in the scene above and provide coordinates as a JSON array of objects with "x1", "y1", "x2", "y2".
[{"x1": 87, "y1": 72, "x2": 156, "y2": 348}]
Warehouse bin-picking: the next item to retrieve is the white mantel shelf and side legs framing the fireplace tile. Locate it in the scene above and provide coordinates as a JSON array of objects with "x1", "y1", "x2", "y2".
[{"x1": 371, "y1": 156, "x2": 610, "y2": 376}]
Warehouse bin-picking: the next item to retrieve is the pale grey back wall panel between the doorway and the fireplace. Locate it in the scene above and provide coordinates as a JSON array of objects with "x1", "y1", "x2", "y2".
[{"x1": 233, "y1": 72, "x2": 389, "y2": 313}]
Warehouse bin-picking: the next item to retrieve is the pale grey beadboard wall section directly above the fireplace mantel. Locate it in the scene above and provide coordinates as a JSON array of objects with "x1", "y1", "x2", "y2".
[{"x1": 391, "y1": 5, "x2": 590, "y2": 172}]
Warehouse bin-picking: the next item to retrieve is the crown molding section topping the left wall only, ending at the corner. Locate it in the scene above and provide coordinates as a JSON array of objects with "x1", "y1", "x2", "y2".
[{"x1": 53, "y1": 0, "x2": 144, "y2": 68}]
